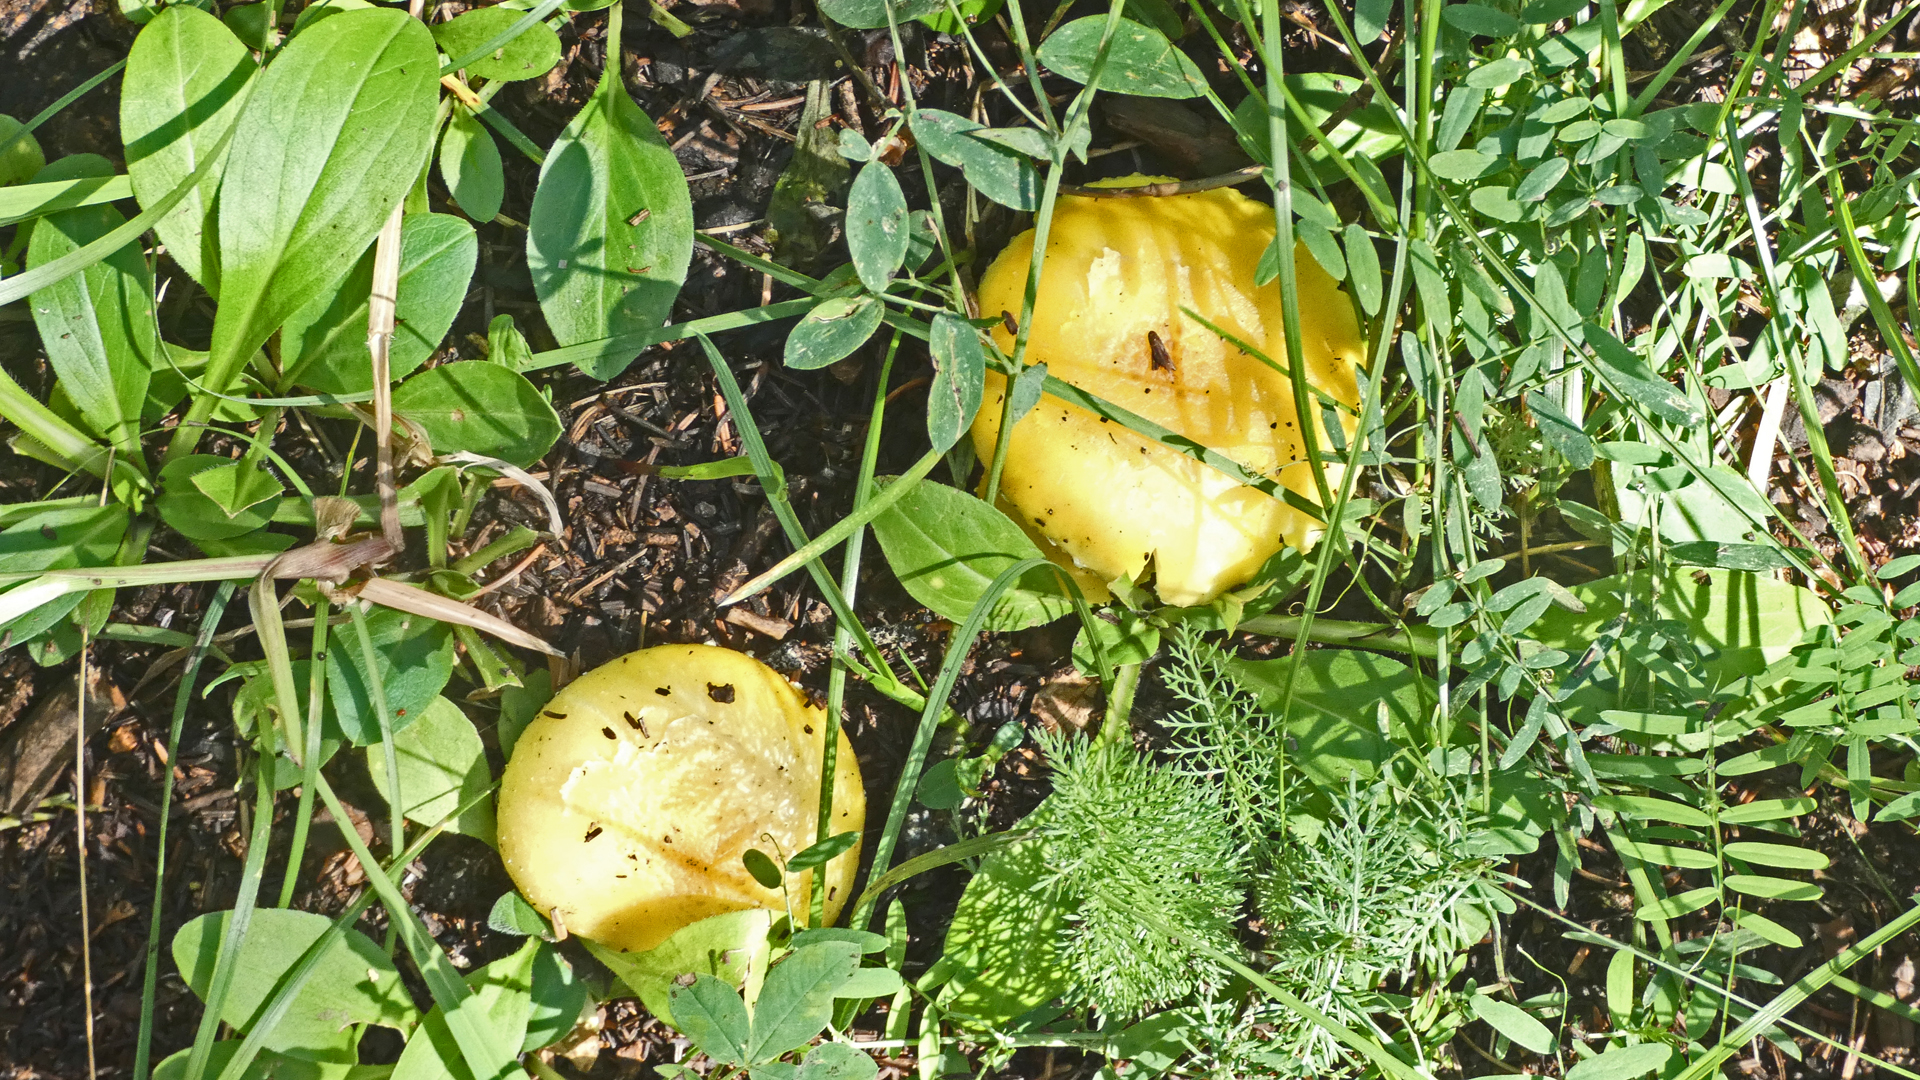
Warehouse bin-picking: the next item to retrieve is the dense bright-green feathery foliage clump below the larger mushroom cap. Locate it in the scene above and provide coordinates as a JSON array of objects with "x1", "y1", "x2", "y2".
[{"x1": 1029, "y1": 722, "x2": 1246, "y2": 1017}]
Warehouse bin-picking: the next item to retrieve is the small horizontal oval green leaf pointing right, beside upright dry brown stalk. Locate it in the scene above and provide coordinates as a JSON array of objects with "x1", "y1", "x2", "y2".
[{"x1": 394, "y1": 359, "x2": 561, "y2": 467}]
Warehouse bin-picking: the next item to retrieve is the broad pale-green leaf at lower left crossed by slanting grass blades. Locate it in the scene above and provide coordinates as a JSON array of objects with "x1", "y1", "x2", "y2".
[{"x1": 173, "y1": 909, "x2": 419, "y2": 1051}]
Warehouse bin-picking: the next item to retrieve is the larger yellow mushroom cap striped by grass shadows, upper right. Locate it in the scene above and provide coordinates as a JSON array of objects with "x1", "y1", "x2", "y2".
[{"x1": 973, "y1": 188, "x2": 1365, "y2": 605}]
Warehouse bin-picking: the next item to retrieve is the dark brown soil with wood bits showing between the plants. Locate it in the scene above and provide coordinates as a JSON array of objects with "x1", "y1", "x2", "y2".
[{"x1": 11, "y1": 0, "x2": 1920, "y2": 1080}]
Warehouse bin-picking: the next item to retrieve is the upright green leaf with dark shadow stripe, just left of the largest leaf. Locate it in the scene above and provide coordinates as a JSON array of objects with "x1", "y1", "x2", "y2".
[{"x1": 121, "y1": 4, "x2": 259, "y2": 296}]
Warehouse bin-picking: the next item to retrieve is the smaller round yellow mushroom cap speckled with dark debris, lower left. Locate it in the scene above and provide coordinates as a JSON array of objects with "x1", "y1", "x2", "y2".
[{"x1": 499, "y1": 646, "x2": 866, "y2": 949}]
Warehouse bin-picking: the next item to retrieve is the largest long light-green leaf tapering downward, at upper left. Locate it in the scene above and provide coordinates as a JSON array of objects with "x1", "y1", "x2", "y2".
[{"x1": 204, "y1": 8, "x2": 440, "y2": 417}]
